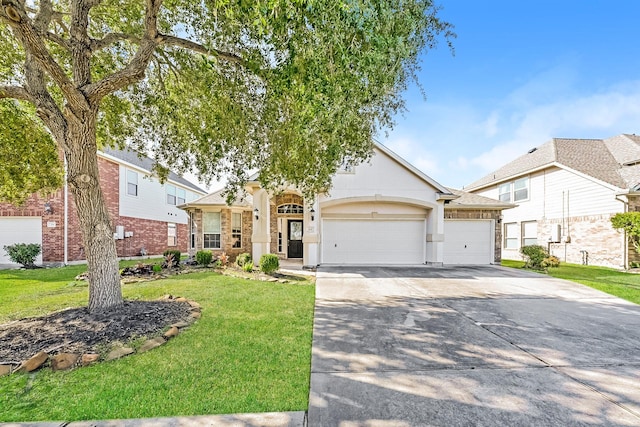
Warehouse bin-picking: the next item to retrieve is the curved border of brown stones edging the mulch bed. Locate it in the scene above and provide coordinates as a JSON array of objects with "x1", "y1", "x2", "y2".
[{"x1": 0, "y1": 295, "x2": 202, "y2": 377}]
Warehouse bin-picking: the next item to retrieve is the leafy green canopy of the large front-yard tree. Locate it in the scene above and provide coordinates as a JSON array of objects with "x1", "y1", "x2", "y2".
[{"x1": 0, "y1": 0, "x2": 452, "y2": 200}]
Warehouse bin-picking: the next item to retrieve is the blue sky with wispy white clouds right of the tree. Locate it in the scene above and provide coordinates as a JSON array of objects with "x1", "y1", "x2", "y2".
[{"x1": 378, "y1": 0, "x2": 640, "y2": 188}]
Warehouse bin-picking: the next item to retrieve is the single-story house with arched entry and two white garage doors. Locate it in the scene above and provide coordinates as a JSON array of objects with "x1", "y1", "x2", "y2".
[{"x1": 180, "y1": 143, "x2": 513, "y2": 267}]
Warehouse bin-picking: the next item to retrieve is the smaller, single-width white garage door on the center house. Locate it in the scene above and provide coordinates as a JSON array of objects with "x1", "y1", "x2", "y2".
[{"x1": 443, "y1": 220, "x2": 493, "y2": 265}]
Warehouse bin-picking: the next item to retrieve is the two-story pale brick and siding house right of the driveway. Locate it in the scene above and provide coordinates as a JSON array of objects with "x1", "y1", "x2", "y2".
[{"x1": 465, "y1": 134, "x2": 640, "y2": 268}]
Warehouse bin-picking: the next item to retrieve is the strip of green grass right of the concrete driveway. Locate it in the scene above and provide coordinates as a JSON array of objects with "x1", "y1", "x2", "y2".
[{"x1": 502, "y1": 260, "x2": 640, "y2": 304}]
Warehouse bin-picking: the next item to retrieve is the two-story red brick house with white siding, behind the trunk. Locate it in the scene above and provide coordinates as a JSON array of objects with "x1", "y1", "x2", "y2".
[{"x1": 0, "y1": 149, "x2": 206, "y2": 264}]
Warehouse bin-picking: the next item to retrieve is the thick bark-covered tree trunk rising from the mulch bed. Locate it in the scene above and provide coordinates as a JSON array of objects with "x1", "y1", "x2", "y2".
[{"x1": 63, "y1": 109, "x2": 123, "y2": 312}]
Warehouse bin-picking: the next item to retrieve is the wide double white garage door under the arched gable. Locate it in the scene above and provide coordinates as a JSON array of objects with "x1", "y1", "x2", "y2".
[{"x1": 322, "y1": 219, "x2": 425, "y2": 265}]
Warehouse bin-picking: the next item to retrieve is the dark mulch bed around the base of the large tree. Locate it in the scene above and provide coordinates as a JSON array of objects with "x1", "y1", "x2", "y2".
[{"x1": 0, "y1": 301, "x2": 191, "y2": 363}]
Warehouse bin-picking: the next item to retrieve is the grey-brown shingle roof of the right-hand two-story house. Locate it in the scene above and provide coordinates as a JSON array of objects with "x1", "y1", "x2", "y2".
[{"x1": 465, "y1": 134, "x2": 640, "y2": 191}]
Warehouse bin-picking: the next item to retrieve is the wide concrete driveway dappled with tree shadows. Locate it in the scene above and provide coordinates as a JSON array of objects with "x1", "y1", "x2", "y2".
[{"x1": 308, "y1": 267, "x2": 640, "y2": 427}]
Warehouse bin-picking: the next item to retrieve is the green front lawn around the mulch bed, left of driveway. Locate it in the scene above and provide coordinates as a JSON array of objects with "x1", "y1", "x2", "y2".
[{"x1": 0, "y1": 267, "x2": 314, "y2": 422}]
